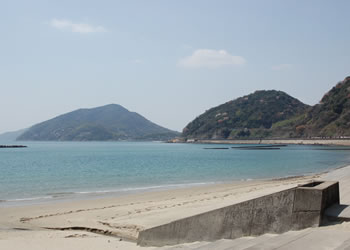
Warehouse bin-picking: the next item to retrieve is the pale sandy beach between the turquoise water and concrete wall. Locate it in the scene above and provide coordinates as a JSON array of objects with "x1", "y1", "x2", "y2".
[{"x1": 0, "y1": 166, "x2": 336, "y2": 250}]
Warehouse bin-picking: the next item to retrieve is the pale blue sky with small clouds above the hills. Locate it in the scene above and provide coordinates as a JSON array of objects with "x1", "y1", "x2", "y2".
[{"x1": 0, "y1": 0, "x2": 350, "y2": 133}]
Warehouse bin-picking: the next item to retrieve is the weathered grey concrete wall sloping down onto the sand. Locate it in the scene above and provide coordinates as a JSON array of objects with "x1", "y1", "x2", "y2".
[{"x1": 138, "y1": 182, "x2": 339, "y2": 246}]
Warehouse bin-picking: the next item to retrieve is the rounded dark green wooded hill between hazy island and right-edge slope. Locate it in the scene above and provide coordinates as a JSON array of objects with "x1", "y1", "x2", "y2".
[{"x1": 183, "y1": 90, "x2": 309, "y2": 139}]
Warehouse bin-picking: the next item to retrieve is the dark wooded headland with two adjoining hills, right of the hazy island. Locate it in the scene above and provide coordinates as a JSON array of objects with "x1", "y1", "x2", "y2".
[{"x1": 181, "y1": 77, "x2": 350, "y2": 140}]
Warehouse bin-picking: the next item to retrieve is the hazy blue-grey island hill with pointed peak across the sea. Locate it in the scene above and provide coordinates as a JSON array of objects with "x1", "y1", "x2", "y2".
[{"x1": 17, "y1": 104, "x2": 179, "y2": 141}]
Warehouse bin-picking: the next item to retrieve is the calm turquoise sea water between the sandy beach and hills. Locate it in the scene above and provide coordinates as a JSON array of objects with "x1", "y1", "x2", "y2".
[{"x1": 0, "y1": 142, "x2": 350, "y2": 206}]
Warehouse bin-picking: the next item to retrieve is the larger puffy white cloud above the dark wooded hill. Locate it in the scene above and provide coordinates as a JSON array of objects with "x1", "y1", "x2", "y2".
[{"x1": 178, "y1": 49, "x2": 246, "y2": 68}]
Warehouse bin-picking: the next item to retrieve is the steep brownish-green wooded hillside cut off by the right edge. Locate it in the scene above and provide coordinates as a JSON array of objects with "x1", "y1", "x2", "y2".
[{"x1": 280, "y1": 77, "x2": 350, "y2": 137}]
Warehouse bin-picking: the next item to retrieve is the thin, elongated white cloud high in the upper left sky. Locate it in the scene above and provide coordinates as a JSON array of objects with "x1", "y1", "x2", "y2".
[{"x1": 50, "y1": 19, "x2": 107, "y2": 33}]
